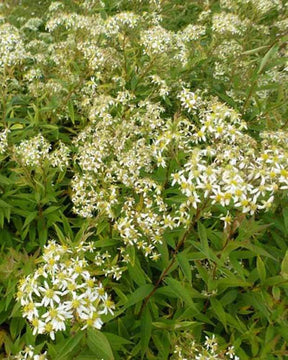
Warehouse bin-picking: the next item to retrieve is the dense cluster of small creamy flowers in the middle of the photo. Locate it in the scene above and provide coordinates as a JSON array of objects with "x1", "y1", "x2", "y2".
[{"x1": 72, "y1": 94, "x2": 178, "y2": 260}]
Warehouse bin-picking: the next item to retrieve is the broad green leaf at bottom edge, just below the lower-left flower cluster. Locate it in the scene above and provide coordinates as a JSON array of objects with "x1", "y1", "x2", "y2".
[{"x1": 87, "y1": 328, "x2": 114, "y2": 360}]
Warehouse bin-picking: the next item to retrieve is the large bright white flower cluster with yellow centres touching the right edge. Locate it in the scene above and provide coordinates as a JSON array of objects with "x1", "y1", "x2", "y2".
[{"x1": 172, "y1": 90, "x2": 288, "y2": 218}]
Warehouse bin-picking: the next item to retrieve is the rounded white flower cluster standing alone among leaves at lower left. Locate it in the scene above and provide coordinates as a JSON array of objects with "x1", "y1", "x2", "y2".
[{"x1": 17, "y1": 241, "x2": 114, "y2": 340}]
